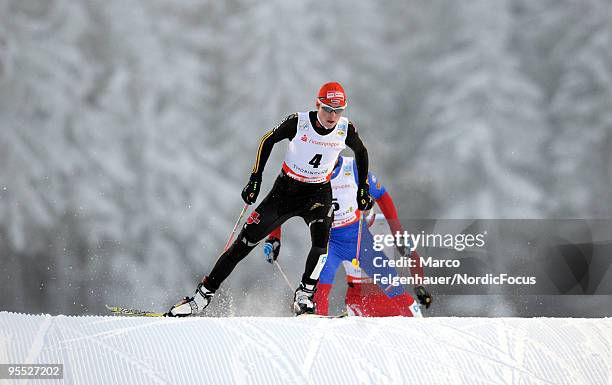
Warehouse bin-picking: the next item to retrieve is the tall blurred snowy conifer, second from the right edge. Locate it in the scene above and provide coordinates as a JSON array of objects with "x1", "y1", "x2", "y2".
[{"x1": 414, "y1": 1, "x2": 547, "y2": 218}]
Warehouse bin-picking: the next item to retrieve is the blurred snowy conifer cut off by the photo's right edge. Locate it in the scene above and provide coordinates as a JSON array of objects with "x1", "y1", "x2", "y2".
[{"x1": 551, "y1": 10, "x2": 612, "y2": 218}]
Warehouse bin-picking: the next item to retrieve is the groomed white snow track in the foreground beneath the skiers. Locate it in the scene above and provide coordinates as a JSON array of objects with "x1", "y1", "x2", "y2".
[{"x1": 0, "y1": 312, "x2": 612, "y2": 385}]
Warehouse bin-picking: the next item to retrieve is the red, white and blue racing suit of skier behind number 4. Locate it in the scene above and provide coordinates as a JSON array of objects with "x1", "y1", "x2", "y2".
[{"x1": 271, "y1": 156, "x2": 423, "y2": 317}]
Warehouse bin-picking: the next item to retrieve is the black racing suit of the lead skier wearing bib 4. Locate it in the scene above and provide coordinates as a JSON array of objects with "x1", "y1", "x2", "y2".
[{"x1": 204, "y1": 111, "x2": 368, "y2": 291}]
